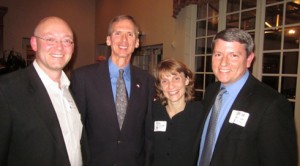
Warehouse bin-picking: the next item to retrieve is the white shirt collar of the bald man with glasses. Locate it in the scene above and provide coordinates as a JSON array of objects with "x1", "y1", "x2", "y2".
[{"x1": 33, "y1": 60, "x2": 70, "y2": 89}]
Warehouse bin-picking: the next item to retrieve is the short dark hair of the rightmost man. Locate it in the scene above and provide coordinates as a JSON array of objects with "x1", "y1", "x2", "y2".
[{"x1": 212, "y1": 28, "x2": 254, "y2": 56}]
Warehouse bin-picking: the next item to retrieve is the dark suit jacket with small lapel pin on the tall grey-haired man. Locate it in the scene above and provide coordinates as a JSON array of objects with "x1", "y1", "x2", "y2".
[{"x1": 71, "y1": 61, "x2": 154, "y2": 166}]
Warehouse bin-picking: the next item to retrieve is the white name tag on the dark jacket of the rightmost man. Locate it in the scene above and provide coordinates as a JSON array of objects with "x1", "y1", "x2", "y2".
[{"x1": 229, "y1": 110, "x2": 250, "y2": 127}]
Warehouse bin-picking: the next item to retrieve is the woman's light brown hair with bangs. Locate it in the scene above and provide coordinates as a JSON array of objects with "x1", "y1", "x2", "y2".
[{"x1": 154, "y1": 59, "x2": 195, "y2": 105}]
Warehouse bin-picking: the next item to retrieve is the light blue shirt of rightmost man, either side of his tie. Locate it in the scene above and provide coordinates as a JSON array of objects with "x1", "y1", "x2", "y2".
[{"x1": 197, "y1": 70, "x2": 249, "y2": 166}]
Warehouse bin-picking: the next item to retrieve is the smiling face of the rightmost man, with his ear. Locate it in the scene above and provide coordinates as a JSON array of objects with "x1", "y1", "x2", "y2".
[{"x1": 212, "y1": 39, "x2": 254, "y2": 85}]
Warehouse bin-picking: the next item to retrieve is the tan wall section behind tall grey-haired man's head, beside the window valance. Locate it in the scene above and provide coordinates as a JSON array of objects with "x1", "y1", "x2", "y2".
[{"x1": 96, "y1": 0, "x2": 191, "y2": 62}]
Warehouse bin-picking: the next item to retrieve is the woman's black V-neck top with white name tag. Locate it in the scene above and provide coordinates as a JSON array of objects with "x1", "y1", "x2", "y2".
[{"x1": 152, "y1": 101, "x2": 203, "y2": 166}]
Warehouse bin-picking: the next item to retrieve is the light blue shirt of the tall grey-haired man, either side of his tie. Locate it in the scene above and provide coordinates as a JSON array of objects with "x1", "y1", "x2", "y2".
[{"x1": 108, "y1": 58, "x2": 131, "y2": 101}]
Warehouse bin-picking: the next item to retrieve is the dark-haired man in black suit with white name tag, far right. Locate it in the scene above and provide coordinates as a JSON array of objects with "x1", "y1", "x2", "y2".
[{"x1": 198, "y1": 28, "x2": 297, "y2": 166}]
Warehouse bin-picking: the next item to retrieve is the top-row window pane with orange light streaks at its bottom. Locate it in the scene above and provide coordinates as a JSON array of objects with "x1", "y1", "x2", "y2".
[{"x1": 265, "y1": 4, "x2": 283, "y2": 28}]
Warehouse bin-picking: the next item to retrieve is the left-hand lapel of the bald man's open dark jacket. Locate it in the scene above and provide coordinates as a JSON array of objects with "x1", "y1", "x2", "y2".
[{"x1": 28, "y1": 66, "x2": 69, "y2": 161}]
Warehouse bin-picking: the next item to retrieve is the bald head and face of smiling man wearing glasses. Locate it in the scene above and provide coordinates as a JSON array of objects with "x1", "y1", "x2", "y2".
[{"x1": 31, "y1": 20, "x2": 74, "y2": 72}]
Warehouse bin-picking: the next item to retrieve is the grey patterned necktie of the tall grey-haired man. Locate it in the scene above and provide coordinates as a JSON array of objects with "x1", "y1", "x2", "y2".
[{"x1": 116, "y1": 69, "x2": 128, "y2": 129}]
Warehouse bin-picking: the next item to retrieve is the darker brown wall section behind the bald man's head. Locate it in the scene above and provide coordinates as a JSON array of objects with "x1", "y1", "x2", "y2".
[{"x1": 0, "y1": 0, "x2": 95, "y2": 68}]
